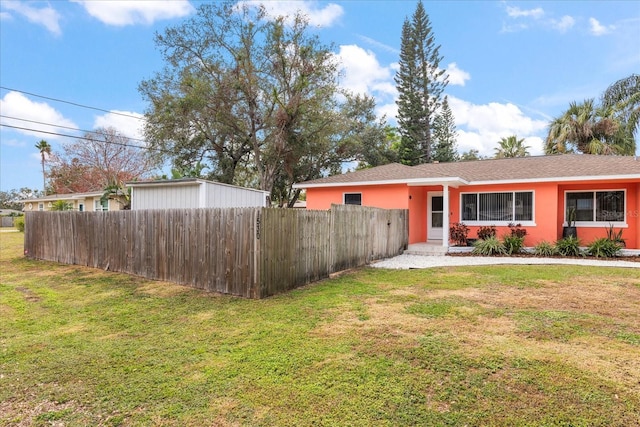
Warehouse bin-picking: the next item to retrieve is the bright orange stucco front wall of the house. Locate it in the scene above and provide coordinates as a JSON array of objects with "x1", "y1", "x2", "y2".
[{"x1": 307, "y1": 181, "x2": 640, "y2": 249}]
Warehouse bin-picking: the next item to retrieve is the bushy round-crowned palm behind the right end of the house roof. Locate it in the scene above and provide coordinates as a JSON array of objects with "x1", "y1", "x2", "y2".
[{"x1": 545, "y1": 98, "x2": 635, "y2": 155}]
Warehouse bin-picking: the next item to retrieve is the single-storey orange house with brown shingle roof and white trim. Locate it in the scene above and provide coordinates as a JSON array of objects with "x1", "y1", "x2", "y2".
[{"x1": 294, "y1": 154, "x2": 640, "y2": 249}]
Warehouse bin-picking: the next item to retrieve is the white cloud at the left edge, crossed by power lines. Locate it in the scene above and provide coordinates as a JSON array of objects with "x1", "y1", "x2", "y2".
[{"x1": 0, "y1": 92, "x2": 78, "y2": 140}]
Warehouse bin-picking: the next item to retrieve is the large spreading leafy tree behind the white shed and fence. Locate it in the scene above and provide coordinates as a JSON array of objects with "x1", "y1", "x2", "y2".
[{"x1": 140, "y1": 2, "x2": 383, "y2": 204}]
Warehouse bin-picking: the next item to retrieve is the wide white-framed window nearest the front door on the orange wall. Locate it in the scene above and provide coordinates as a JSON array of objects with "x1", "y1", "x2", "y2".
[{"x1": 460, "y1": 191, "x2": 533, "y2": 224}]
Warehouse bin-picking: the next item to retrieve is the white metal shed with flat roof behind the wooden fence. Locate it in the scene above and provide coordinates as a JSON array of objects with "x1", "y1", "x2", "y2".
[{"x1": 126, "y1": 178, "x2": 269, "y2": 210}]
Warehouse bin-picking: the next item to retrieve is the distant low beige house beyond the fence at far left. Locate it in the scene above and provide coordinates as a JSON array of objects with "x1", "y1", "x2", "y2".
[{"x1": 21, "y1": 191, "x2": 126, "y2": 212}]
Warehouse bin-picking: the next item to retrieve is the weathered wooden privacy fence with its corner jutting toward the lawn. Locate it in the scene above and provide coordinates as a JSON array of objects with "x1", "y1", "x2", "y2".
[{"x1": 25, "y1": 205, "x2": 408, "y2": 298}]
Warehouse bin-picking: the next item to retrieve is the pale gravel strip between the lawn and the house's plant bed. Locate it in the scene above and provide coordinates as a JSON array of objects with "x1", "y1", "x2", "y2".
[{"x1": 371, "y1": 255, "x2": 640, "y2": 270}]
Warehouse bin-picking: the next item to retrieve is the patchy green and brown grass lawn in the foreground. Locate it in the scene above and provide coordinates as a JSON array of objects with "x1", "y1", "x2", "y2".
[{"x1": 0, "y1": 233, "x2": 640, "y2": 426}]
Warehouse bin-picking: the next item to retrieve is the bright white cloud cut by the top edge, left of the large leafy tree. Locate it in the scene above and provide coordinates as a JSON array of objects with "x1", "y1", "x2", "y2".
[{"x1": 71, "y1": 0, "x2": 194, "y2": 27}]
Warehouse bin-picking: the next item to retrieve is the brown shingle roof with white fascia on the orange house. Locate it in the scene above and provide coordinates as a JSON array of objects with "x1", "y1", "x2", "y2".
[{"x1": 296, "y1": 154, "x2": 640, "y2": 188}]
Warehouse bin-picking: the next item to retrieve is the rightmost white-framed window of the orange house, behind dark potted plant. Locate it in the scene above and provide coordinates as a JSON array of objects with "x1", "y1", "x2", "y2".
[{"x1": 565, "y1": 190, "x2": 626, "y2": 225}]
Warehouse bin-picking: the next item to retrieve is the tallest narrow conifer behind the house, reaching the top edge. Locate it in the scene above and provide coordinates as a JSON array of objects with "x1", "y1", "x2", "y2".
[{"x1": 395, "y1": 1, "x2": 448, "y2": 165}]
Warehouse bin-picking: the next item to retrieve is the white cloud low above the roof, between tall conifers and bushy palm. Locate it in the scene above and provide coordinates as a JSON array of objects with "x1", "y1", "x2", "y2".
[{"x1": 449, "y1": 96, "x2": 547, "y2": 156}]
